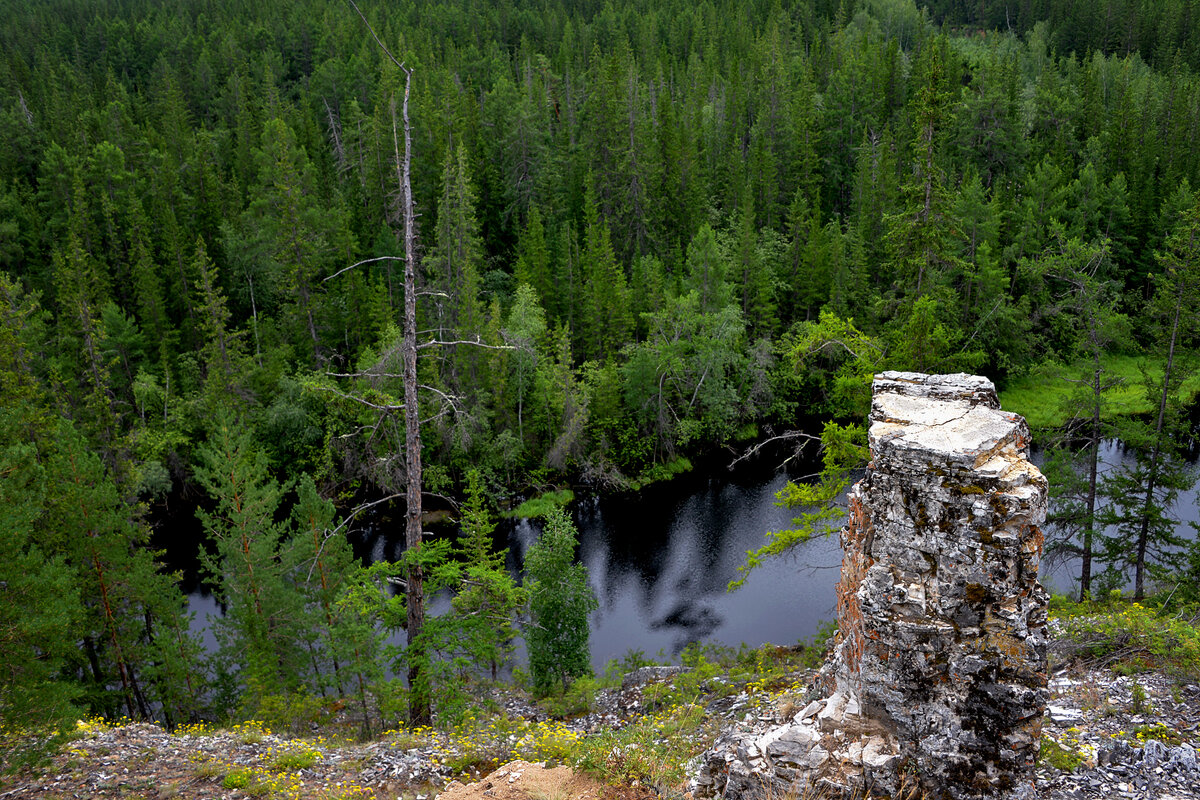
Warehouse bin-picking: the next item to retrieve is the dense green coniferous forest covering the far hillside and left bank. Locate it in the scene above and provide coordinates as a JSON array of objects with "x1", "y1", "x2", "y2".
[{"x1": 0, "y1": 0, "x2": 1200, "y2": 748}]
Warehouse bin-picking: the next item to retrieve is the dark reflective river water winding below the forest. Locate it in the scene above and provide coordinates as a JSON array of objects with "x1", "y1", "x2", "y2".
[{"x1": 174, "y1": 440, "x2": 1200, "y2": 668}]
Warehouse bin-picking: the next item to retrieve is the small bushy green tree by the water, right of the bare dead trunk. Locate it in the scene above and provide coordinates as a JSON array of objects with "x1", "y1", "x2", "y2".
[{"x1": 524, "y1": 509, "x2": 599, "y2": 693}]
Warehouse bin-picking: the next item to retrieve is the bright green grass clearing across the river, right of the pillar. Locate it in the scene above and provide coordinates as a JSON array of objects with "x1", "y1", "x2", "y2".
[{"x1": 1000, "y1": 355, "x2": 1200, "y2": 428}]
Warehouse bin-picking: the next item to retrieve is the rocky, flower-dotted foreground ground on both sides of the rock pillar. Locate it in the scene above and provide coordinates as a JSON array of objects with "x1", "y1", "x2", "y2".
[{"x1": 0, "y1": 667, "x2": 1200, "y2": 800}]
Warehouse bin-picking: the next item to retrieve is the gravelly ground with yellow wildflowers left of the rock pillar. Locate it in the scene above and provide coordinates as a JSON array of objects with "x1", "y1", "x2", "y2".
[{"x1": 0, "y1": 668, "x2": 657, "y2": 800}]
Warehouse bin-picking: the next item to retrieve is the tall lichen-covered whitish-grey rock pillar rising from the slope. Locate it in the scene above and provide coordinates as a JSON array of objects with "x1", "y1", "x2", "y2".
[{"x1": 694, "y1": 372, "x2": 1049, "y2": 800}]
